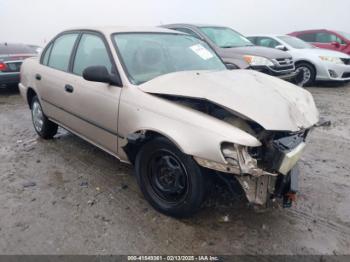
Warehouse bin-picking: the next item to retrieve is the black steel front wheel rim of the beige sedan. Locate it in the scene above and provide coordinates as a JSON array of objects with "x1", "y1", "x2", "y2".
[{"x1": 147, "y1": 149, "x2": 189, "y2": 204}]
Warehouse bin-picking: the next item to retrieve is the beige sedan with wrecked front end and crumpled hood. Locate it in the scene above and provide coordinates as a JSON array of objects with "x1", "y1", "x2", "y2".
[{"x1": 19, "y1": 27, "x2": 318, "y2": 217}]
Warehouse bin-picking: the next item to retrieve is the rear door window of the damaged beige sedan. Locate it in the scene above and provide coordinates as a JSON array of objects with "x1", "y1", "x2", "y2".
[{"x1": 48, "y1": 34, "x2": 78, "y2": 71}]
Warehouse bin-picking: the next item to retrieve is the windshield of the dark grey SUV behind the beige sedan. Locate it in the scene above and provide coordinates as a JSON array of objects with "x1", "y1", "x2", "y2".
[{"x1": 200, "y1": 27, "x2": 253, "y2": 48}]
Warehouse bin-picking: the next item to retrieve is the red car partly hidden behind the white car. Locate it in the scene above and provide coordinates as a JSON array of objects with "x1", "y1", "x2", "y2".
[{"x1": 289, "y1": 29, "x2": 350, "y2": 55}]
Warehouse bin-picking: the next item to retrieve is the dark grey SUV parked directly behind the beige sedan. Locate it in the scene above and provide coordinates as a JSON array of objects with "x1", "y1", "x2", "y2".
[{"x1": 162, "y1": 24, "x2": 296, "y2": 81}]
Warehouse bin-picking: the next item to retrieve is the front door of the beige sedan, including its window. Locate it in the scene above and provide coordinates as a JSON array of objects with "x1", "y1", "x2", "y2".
[{"x1": 62, "y1": 32, "x2": 122, "y2": 154}]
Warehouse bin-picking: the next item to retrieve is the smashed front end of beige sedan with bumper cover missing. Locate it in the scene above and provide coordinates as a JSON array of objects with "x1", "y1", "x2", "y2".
[{"x1": 194, "y1": 132, "x2": 307, "y2": 207}]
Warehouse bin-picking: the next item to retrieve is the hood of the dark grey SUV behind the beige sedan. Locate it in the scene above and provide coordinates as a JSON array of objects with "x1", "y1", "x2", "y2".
[{"x1": 218, "y1": 46, "x2": 291, "y2": 59}]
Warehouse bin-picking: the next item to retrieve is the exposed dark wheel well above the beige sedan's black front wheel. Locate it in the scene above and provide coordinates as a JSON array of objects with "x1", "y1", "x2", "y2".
[{"x1": 123, "y1": 130, "x2": 172, "y2": 164}]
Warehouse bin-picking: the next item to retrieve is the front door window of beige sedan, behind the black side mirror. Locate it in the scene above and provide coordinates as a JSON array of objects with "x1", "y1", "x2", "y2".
[{"x1": 73, "y1": 34, "x2": 112, "y2": 76}]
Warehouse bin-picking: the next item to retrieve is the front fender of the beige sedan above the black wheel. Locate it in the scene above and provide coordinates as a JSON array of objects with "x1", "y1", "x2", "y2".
[{"x1": 118, "y1": 88, "x2": 261, "y2": 163}]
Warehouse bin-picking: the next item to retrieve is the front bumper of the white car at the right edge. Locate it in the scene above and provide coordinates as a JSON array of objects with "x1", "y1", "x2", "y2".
[{"x1": 316, "y1": 62, "x2": 350, "y2": 82}]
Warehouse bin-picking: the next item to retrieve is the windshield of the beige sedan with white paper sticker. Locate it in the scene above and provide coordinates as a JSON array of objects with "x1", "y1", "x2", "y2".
[{"x1": 113, "y1": 33, "x2": 226, "y2": 85}]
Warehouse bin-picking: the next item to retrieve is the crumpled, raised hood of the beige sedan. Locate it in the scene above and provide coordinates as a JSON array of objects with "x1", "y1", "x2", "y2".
[{"x1": 139, "y1": 70, "x2": 319, "y2": 132}]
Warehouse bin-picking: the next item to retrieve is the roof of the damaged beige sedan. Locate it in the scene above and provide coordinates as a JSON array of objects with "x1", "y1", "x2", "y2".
[{"x1": 65, "y1": 26, "x2": 180, "y2": 35}]
